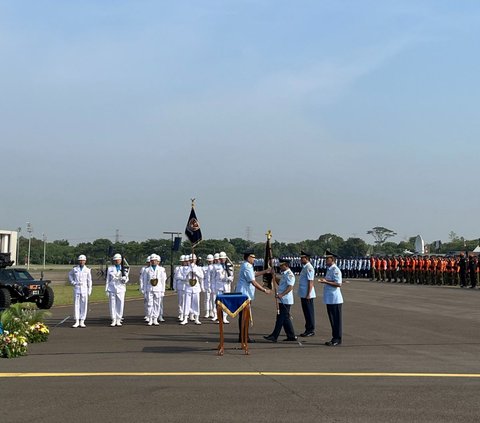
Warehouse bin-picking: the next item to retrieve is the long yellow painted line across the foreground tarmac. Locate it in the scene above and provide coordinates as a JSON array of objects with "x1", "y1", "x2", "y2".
[{"x1": 0, "y1": 372, "x2": 480, "y2": 379}]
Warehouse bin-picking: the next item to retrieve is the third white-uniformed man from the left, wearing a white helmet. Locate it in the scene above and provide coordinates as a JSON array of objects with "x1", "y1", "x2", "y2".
[{"x1": 142, "y1": 254, "x2": 167, "y2": 326}]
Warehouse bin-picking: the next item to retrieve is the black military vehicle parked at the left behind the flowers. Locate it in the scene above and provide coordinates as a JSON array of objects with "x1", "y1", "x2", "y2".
[{"x1": 0, "y1": 253, "x2": 54, "y2": 310}]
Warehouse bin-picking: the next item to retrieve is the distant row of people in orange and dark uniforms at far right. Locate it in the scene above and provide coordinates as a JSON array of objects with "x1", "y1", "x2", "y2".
[{"x1": 370, "y1": 253, "x2": 480, "y2": 288}]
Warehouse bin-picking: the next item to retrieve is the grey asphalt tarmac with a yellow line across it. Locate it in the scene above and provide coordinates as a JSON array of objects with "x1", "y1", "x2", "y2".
[{"x1": 0, "y1": 280, "x2": 480, "y2": 423}]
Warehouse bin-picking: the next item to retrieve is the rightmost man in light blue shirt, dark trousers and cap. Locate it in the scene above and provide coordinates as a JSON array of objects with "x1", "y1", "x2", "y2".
[{"x1": 318, "y1": 251, "x2": 343, "y2": 347}]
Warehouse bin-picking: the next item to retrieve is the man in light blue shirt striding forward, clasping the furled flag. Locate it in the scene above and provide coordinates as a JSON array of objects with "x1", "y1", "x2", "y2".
[{"x1": 264, "y1": 259, "x2": 297, "y2": 342}]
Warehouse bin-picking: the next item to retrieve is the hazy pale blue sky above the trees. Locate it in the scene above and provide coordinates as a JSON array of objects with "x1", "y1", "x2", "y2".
[{"x1": 0, "y1": 0, "x2": 480, "y2": 243}]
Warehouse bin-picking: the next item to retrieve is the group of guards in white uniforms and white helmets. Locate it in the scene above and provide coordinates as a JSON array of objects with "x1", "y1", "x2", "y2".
[{"x1": 69, "y1": 252, "x2": 234, "y2": 328}]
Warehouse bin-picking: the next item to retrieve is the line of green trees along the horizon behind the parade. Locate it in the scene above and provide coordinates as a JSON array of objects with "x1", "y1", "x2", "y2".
[{"x1": 15, "y1": 233, "x2": 478, "y2": 265}]
